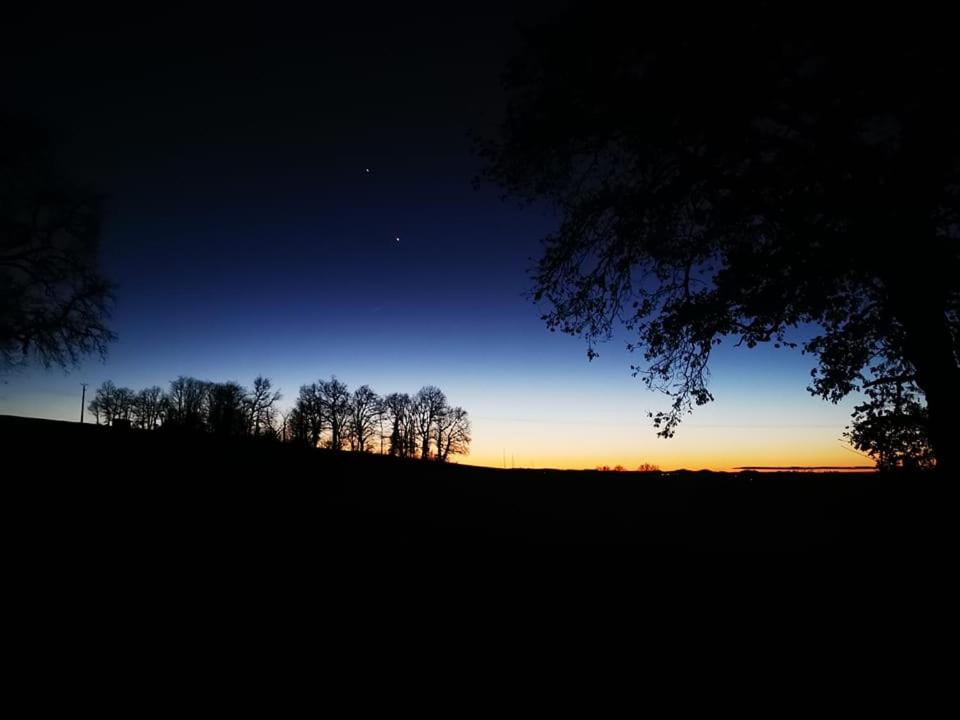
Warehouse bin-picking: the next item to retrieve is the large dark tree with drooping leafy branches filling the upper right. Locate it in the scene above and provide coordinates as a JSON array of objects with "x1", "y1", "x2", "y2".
[{"x1": 480, "y1": 2, "x2": 960, "y2": 468}]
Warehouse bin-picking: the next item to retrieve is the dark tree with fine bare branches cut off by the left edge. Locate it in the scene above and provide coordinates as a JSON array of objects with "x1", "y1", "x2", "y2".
[{"x1": 0, "y1": 113, "x2": 114, "y2": 369}]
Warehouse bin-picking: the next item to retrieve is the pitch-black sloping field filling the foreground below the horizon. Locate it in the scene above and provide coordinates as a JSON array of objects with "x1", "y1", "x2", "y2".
[{"x1": 0, "y1": 417, "x2": 956, "y2": 696}]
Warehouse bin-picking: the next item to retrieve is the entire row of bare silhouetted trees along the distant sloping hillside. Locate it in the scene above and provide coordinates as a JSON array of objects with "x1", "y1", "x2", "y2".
[{"x1": 87, "y1": 375, "x2": 470, "y2": 462}]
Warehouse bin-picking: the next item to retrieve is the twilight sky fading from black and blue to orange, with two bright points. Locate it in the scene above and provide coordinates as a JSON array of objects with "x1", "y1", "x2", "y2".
[{"x1": 0, "y1": 3, "x2": 869, "y2": 470}]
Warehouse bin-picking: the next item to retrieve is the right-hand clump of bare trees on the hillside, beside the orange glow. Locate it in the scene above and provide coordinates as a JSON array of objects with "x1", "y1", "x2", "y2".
[{"x1": 285, "y1": 377, "x2": 470, "y2": 462}]
